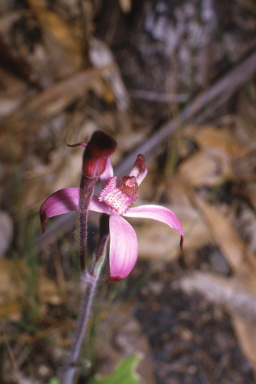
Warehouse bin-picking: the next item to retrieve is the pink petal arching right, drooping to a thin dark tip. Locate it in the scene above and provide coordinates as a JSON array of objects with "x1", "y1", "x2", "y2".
[{"x1": 124, "y1": 205, "x2": 184, "y2": 249}]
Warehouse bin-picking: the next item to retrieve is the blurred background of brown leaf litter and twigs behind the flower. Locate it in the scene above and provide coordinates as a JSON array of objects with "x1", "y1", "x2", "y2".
[{"x1": 0, "y1": 0, "x2": 256, "y2": 384}]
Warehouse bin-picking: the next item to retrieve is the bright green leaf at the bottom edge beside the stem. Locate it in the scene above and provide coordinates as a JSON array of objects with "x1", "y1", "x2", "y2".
[{"x1": 90, "y1": 354, "x2": 141, "y2": 384}]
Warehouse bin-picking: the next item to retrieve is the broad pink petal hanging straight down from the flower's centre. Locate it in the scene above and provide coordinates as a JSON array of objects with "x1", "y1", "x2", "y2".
[{"x1": 107, "y1": 215, "x2": 138, "y2": 283}]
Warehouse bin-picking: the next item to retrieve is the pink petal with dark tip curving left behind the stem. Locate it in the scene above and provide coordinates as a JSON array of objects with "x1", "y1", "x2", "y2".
[{"x1": 40, "y1": 188, "x2": 79, "y2": 232}]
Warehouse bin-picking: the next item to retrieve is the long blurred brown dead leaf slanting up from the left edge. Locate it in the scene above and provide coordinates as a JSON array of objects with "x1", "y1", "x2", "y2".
[{"x1": 0, "y1": 69, "x2": 101, "y2": 161}]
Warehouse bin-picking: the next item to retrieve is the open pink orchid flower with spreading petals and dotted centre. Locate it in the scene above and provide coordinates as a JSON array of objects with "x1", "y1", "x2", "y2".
[{"x1": 40, "y1": 155, "x2": 183, "y2": 282}]
